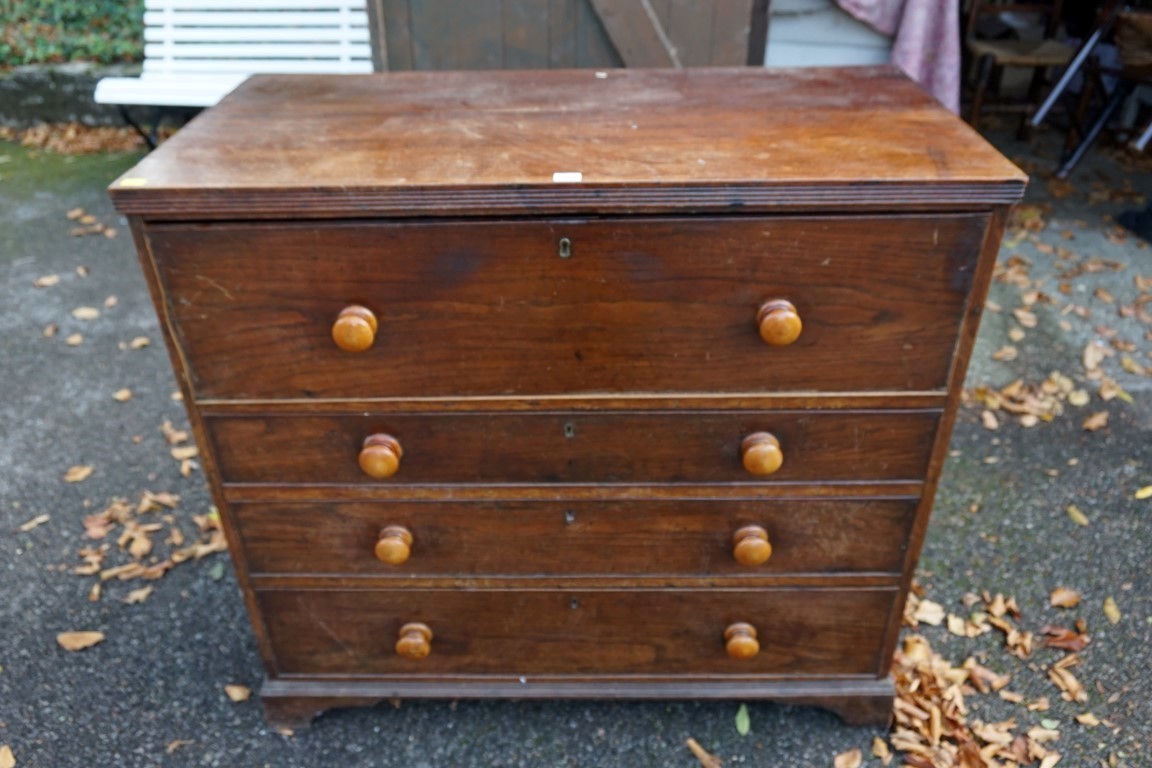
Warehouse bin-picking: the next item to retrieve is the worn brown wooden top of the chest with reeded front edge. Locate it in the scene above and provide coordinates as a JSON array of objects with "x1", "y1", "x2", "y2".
[{"x1": 111, "y1": 67, "x2": 1026, "y2": 219}]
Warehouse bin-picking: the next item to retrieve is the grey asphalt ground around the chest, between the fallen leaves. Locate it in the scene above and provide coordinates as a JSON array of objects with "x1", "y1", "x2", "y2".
[{"x1": 0, "y1": 127, "x2": 1152, "y2": 768}]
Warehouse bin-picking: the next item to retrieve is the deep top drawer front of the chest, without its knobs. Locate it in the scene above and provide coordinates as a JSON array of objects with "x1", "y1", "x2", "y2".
[{"x1": 147, "y1": 214, "x2": 987, "y2": 398}]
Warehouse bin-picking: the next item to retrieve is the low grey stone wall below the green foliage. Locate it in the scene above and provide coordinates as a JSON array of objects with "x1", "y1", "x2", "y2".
[{"x1": 0, "y1": 62, "x2": 139, "y2": 128}]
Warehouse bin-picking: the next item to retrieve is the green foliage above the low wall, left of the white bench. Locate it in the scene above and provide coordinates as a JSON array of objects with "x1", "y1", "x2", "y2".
[{"x1": 0, "y1": 0, "x2": 144, "y2": 68}]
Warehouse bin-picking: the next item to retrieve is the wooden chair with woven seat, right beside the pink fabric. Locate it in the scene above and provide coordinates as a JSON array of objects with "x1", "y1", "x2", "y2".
[{"x1": 964, "y1": 0, "x2": 1074, "y2": 134}]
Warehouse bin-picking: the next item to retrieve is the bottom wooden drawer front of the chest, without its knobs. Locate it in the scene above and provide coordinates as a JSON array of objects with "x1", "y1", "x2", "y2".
[{"x1": 257, "y1": 588, "x2": 896, "y2": 676}]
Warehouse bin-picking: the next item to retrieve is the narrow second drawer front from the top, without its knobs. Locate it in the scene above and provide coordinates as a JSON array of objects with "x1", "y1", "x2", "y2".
[{"x1": 205, "y1": 411, "x2": 940, "y2": 485}]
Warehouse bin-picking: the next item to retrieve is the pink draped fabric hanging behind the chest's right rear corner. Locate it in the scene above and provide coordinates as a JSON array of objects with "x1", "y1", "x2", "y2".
[{"x1": 836, "y1": 0, "x2": 960, "y2": 113}]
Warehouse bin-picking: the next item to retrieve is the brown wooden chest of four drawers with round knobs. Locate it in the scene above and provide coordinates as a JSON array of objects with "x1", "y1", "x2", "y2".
[{"x1": 112, "y1": 69, "x2": 1025, "y2": 724}]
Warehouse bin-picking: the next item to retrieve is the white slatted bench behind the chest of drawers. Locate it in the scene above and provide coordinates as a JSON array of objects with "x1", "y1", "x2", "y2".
[{"x1": 94, "y1": 0, "x2": 372, "y2": 140}]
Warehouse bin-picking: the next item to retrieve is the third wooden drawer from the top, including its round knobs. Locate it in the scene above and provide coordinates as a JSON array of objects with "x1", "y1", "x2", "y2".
[{"x1": 233, "y1": 499, "x2": 916, "y2": 577}]
